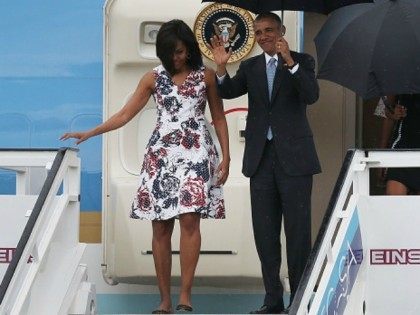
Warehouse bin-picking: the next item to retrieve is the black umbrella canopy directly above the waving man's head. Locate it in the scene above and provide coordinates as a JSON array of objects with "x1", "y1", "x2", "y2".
[{"x1": 202, "y1": 0, "x2": 373, "y2": 14}]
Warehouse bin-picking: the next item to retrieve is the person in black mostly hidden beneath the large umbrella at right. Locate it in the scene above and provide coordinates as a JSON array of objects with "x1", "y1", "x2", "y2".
[{"x1": 386, "y1": 94, "x2": 420, "y2": 195}]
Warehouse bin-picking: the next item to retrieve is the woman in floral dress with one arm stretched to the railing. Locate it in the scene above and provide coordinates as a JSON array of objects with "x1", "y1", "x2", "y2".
[{"x1": 61, "y1": 20, "x2": 230, "y2": 314}]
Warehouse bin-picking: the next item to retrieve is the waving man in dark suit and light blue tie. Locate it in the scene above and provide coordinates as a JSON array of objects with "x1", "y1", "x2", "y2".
[{"x1": 211, "y1": 12, "x2": 321, "y2": 314}]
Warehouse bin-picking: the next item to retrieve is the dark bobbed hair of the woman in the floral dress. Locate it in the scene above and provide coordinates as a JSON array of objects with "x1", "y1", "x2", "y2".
[{"x1": 156, "y1": 20, "x2": 203, "y2": 75}]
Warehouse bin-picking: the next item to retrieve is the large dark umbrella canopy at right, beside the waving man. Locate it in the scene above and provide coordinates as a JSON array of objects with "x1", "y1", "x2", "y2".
[{"x1": 315, "y1": 0, "x2": 420, "y2": 99}]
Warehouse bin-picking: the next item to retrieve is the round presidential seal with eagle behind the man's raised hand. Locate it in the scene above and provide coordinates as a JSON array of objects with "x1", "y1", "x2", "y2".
[{"x1": 194, "y1": 3, "x2": 255, "y2": 63}]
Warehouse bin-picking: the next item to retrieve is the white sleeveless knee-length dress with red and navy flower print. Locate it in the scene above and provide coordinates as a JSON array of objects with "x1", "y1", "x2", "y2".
[{"x1": 130, "y1": 65, "x2": 225, "y2": 220}]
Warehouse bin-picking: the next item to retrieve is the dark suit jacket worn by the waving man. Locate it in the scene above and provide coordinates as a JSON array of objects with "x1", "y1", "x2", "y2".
[{"x1": 218, "y1": 52, "x2": 321, "y2": 177}]
